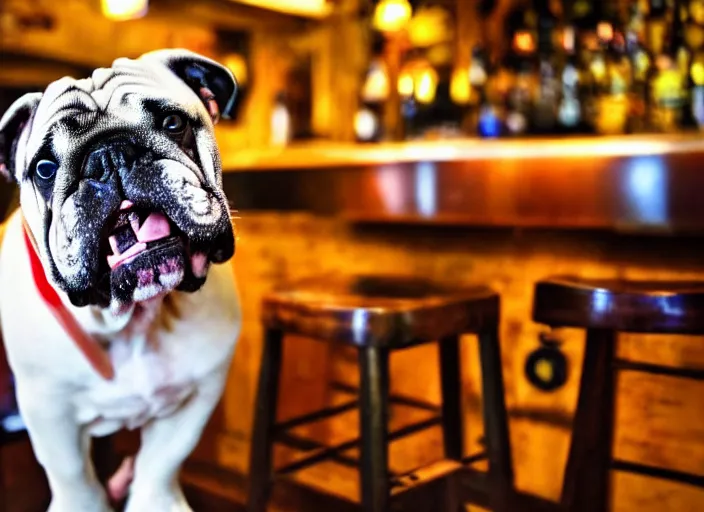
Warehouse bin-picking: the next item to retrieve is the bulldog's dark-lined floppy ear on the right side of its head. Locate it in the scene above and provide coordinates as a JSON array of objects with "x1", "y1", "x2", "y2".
[{"x1": 140, "y1": 49, "x2": 238, "y2": 123}]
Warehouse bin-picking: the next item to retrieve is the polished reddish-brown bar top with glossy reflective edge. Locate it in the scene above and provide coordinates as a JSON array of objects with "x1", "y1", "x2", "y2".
[{"x1": 223, "y1": 134, "x2": 704, "y2": 234}]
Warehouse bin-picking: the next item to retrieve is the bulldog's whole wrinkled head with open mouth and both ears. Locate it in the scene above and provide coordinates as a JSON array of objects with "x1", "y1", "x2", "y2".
[{"x1": 0, "y1": 50, "x2": 237, "y2": 306}]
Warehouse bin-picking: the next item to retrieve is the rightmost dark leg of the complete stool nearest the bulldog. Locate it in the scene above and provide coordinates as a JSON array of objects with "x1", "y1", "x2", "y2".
[{"x1": 479, "y1": 326, "x2": 513, "y2": 512}]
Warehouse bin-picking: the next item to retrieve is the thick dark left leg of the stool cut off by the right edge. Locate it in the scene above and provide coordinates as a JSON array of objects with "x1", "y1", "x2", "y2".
[{"x1": 560, "y1": 329, "x2": 616, "y2": 512}]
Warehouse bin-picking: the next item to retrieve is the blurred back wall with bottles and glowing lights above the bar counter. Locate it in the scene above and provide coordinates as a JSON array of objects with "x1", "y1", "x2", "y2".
[{"x1": 5, "y1": 0, "x2": 704, "y2": 152}]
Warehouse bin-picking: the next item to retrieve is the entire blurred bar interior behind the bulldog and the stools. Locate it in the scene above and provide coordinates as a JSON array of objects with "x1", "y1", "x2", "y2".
[{"x1": 0, "y1": 0, "x2": 704, "y2": 512}]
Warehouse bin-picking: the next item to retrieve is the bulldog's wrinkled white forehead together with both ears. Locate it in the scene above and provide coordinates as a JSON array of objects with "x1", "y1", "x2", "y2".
[{"x1": 0, "y1": 49, "x2": 238, "y2": 186}]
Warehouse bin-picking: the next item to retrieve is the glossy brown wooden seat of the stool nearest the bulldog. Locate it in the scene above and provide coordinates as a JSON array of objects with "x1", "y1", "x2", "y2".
[{"x1": 262, "y1": 275, "x2": 499, "y2": 348}]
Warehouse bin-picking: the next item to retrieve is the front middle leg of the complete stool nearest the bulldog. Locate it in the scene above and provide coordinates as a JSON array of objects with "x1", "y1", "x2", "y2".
[{"x1": 359, "y1": 347, "x2": 389, "y2": 512}]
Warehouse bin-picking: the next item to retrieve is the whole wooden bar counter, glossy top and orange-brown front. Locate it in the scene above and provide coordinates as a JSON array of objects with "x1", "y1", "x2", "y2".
[{"x1": 193, "y1": 135, "x2": 704, "y2": 512}]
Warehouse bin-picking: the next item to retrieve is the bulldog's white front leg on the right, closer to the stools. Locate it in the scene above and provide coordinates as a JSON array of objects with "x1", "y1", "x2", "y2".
[{"x1": 126, "y1": 366, "x2": 227, "y2": 512}]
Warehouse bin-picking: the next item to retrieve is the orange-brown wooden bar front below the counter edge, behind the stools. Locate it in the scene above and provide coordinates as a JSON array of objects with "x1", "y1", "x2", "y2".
[{"x1": 213, "y1": 213, "x2": 704, "y2": 511}]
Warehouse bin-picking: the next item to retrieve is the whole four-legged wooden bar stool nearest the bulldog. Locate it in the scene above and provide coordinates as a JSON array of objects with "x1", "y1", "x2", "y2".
[{"x1": 248, "y1": 276, "x2": 513, "y2": 512}]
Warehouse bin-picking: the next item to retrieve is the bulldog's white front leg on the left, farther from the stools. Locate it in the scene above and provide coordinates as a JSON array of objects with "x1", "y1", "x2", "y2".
[{"x1": 17, "y1": 386, "x2": 111, "y2": 512}]
